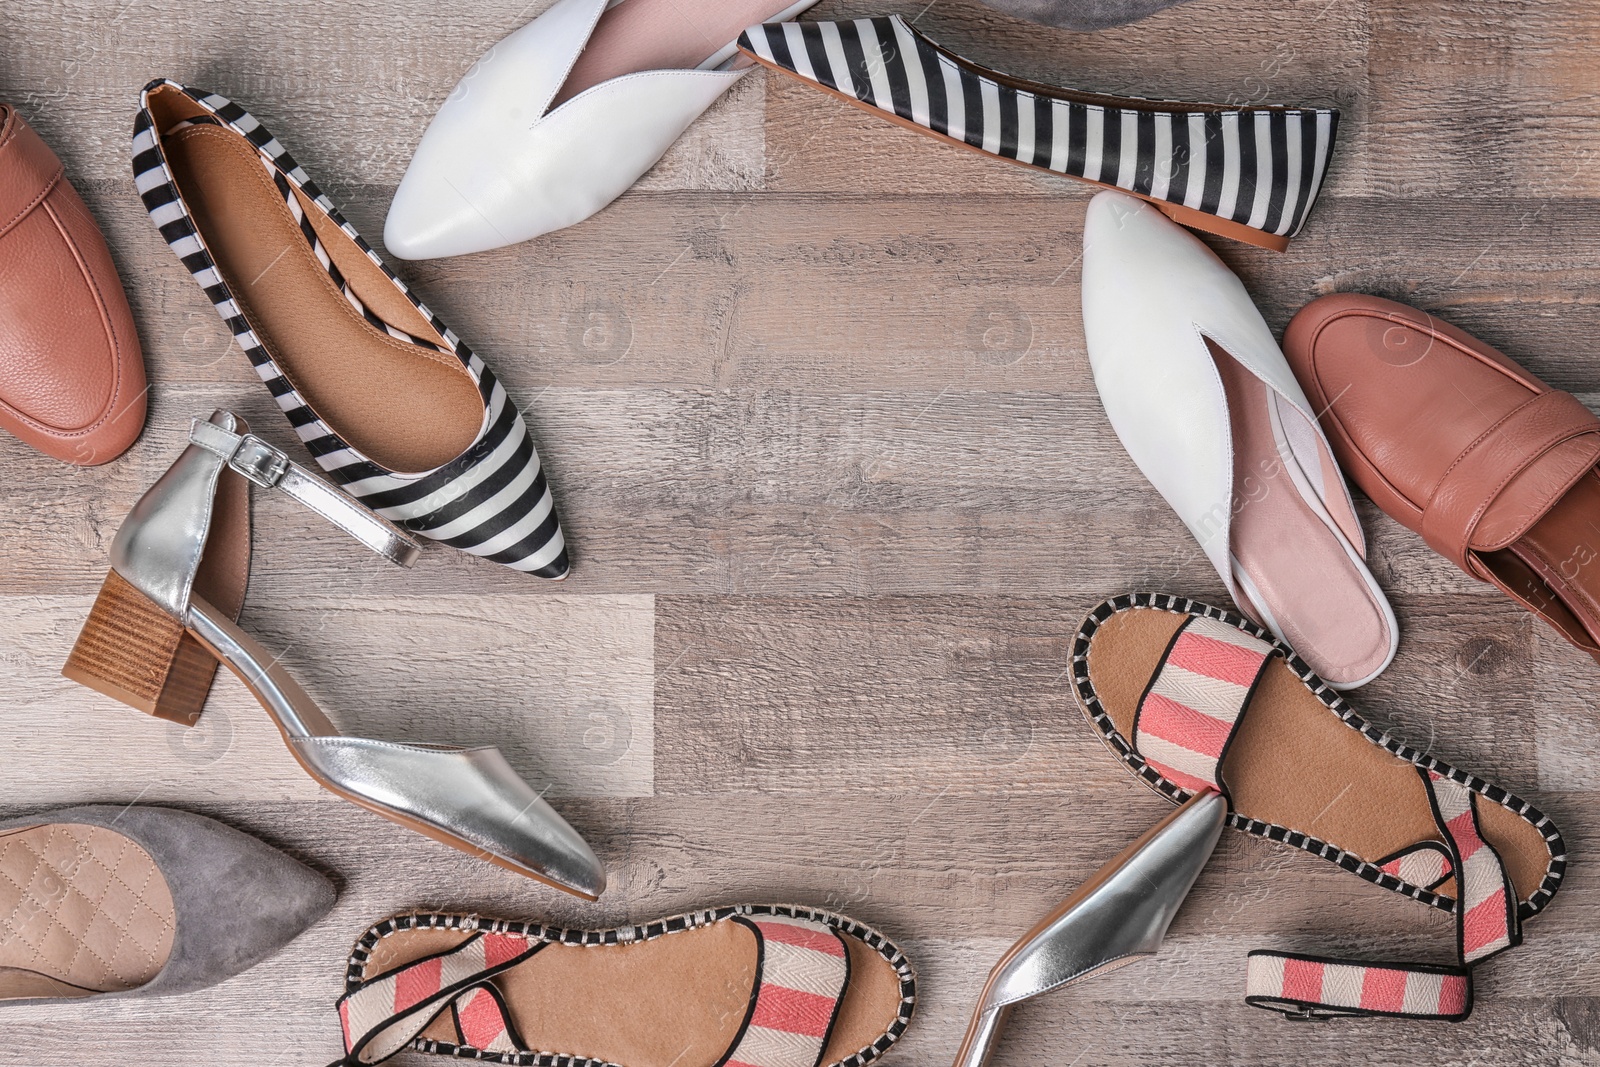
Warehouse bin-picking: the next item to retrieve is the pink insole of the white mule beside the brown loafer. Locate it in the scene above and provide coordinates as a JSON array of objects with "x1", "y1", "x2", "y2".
[{"x1": 1206, "y1": 341, "x2": 1390, "y2": 683}]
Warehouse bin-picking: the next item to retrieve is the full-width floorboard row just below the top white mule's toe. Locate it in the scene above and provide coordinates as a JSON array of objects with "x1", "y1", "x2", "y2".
[{"x1": 46, "y1": 183, "x2": 1600, "y2": 403}]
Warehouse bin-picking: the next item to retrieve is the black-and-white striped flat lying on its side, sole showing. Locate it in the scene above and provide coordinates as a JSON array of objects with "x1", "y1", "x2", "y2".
[{"x1": 739, "y1": 14, "x2": 1339, "y2": 251}]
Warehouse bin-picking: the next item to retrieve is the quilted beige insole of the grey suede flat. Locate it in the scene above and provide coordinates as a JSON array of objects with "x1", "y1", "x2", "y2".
[{"x1": 0, "y1": 822, "x2": 176, "y2": 1001}]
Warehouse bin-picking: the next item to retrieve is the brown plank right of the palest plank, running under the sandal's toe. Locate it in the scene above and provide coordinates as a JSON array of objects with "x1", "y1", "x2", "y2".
[{"x1": 656, "y1": 597, "x2": 1548, "y2": 797}]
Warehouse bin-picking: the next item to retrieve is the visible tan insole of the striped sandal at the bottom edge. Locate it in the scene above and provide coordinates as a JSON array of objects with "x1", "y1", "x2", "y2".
[{"x1": 363, "y1": 921, "x2": 901, "y2": 1067}]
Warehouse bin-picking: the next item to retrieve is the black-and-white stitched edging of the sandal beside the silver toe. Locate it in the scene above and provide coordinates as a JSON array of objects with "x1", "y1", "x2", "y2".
[{"x1": 1070, "y1": 593, "x2": 1566, "y2": 920}]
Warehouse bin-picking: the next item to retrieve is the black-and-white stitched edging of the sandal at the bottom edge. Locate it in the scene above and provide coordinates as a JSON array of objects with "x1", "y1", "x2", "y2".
[{"x1": 344, "y1": 904, "x2": 917, "y2": 1067}]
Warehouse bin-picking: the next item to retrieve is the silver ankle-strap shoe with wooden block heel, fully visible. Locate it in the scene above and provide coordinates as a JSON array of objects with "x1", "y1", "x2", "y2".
[{"x1": 62, "y1": 411, "x2": 605, "y2": 899}]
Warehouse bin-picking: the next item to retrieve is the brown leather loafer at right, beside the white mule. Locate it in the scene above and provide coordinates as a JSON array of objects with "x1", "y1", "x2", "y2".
[{"x1": 1283, "y1": 293, "x2": 1600, "y2": 659}]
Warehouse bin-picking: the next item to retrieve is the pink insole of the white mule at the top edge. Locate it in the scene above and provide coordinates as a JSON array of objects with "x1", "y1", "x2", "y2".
[{"x1": 550, "y1": 0, "x2": 806, "y2": 109}]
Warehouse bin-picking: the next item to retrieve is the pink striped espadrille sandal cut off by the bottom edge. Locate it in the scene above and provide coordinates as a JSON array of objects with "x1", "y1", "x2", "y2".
[{"x1": 338, "y1": 904, "x2": 917, "y2": 1067}]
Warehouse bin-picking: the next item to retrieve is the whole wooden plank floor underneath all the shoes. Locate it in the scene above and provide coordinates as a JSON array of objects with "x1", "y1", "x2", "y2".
[{"x1": 0, "y1": 0, "x2": 1600, "y2": 1067}]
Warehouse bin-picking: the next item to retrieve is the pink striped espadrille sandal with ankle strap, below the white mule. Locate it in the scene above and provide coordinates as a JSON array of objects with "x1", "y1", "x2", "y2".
[{"x1": 1072, "y1": 593, "x2": 1566, "y2": 1022}]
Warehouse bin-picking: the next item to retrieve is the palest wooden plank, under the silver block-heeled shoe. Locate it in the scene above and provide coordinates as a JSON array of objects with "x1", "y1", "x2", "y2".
[{"x1": 0, "y1": 589, "x2": 654, "y2": 805}]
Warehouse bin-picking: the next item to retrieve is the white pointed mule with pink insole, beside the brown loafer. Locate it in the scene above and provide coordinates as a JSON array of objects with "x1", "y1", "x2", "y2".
[{"x1": 1083, "y1": 192, "x2": 1398, "y2": 689}]
